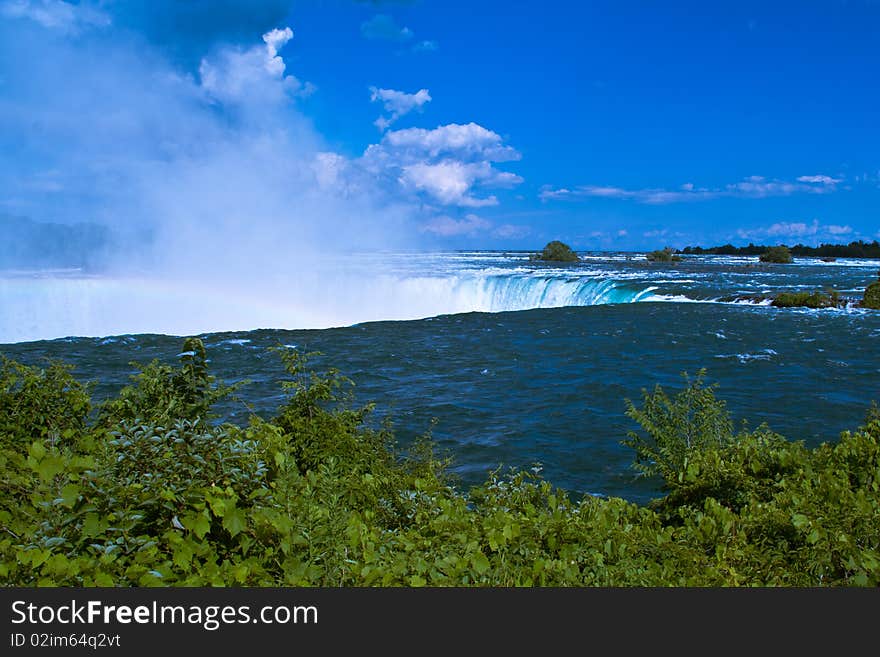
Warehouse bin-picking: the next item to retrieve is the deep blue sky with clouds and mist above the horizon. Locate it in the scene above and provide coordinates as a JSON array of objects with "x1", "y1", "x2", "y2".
[{"x1": 0, "y1": 0, "x2": 880, "y2": 250}]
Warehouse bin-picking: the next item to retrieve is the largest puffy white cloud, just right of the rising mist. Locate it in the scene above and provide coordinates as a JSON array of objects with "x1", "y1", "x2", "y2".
[{"x1": 361, "y1": 123, "x2": 522, "y2": 207}]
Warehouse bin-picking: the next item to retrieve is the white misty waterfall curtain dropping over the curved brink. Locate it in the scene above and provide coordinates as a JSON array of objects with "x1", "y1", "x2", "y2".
[{"x1": 0, "y1": 270, "x2": 646, "y2": 343}]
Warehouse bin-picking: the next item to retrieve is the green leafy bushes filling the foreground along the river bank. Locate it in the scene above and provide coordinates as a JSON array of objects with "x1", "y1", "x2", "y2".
[{"x1": 0, "y1": 339, "x2": 880, "y2": 586}]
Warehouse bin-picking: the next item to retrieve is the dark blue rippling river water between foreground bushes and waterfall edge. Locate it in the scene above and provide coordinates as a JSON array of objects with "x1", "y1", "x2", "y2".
[{"x1": 0, "y1": 288, "x2": 880, "y2": 501}]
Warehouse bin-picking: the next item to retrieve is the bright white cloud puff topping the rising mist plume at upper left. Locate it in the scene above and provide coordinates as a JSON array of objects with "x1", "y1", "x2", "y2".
[{"x1": 199, "y1": 27, "x2": 315, "y2": 105}]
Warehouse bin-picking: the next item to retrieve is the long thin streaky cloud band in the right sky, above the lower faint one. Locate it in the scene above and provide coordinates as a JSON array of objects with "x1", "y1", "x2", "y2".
[{"x1": 539, "y1": 175, "x2": 843, "y2": 205}]
